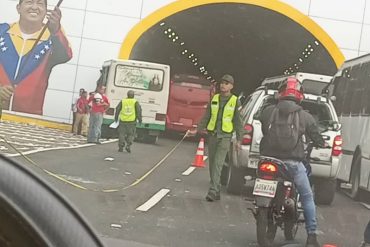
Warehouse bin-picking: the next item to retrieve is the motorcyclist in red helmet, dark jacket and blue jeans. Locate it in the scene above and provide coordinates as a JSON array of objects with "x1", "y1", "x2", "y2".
[{"x1": 260, "y1": 77, "x2": 327, "y2": 247}]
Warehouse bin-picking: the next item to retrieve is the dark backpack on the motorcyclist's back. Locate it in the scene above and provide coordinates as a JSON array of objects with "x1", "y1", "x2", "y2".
[{"x1": 267, "y1": 107, "x2": 300, "y2": 152}]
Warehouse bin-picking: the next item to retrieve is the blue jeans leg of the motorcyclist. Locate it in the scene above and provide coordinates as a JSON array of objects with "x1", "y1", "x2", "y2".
[{"x1": 284, "y1": 160, "x2": 317, "y2": 234}]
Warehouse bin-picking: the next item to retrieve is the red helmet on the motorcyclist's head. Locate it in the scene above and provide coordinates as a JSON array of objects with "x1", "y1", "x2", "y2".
[{"x1": 278, "y1": 77, "x2": 304, "y2": 103}]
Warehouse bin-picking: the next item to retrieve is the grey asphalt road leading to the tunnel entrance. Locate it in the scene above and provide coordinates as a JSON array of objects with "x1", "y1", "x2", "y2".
[{"x1": 6, "y1": 133, "x2": 370, "y2": 247}]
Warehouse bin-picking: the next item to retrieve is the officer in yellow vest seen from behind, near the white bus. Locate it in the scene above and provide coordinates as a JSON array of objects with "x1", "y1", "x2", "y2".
[{"x1": 115, "y1": 90, "x2": 142, "y2": 153}]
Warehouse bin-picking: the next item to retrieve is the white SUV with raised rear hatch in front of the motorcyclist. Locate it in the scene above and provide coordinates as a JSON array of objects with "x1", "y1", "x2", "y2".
[{"x1": 223, "y1": 73, "x2": 342, "y2": 204}]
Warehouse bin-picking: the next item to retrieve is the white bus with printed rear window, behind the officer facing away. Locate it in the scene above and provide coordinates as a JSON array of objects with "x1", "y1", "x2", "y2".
[{"x1": 101, "y1": 59, "x2": 170, "y2": 143}]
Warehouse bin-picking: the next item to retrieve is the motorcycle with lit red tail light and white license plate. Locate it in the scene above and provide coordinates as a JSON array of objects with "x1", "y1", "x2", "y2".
[{"x1": 253, "y1": 156, "x2": 304, "y2": 247}]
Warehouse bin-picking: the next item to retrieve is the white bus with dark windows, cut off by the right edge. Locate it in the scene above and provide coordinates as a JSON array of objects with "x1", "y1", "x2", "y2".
[{"x1": 333, "y1": 54, "x2": 370, "y2": 199}]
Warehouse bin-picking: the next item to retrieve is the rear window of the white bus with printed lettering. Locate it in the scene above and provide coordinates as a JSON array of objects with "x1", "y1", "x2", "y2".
[{"x1": 114, "y1": 65, "x2": 164, "y2": 91}]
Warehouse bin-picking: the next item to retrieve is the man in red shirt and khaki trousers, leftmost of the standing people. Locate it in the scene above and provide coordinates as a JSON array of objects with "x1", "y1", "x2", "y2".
[{"x1": 73, "y1": 90, "x2": 89, "y2": 136}]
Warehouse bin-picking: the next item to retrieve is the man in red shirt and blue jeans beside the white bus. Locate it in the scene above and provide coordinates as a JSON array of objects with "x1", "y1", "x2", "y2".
[{"x1": 87, "y1": 86, "x2": 110, "y2": 144}]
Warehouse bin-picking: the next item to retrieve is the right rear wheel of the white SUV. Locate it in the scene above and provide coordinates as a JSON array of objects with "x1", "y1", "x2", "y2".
[{"x1": 314, "y1": 178, "x2": 337, "y2": 205}]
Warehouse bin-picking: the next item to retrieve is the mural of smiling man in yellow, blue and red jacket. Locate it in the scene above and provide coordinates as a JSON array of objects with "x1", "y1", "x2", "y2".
[{"x1": 0, "y1": 0, "x2": 72, "y2": 115}]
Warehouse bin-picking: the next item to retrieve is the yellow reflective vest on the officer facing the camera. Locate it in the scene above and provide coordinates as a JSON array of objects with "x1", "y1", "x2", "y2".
[{"x1": 207, "y1": 94, "x2": 238, "y2": 133}]
